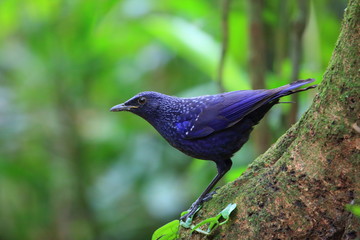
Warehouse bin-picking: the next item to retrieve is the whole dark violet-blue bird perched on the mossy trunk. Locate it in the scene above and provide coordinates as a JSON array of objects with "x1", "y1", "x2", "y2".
[{"x1": 110, "y1": 78, "x2": 317, "y2": 221}]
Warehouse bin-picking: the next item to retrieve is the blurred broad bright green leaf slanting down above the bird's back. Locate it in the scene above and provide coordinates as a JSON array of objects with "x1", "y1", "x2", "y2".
[{"x1": 144, "y1": 17, "x2": 250, "y2": 90}]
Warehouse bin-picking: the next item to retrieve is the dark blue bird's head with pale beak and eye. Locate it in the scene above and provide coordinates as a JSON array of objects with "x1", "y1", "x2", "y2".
[{"x1": 110, "y1": 92, "x2": 170, "y2": 120}]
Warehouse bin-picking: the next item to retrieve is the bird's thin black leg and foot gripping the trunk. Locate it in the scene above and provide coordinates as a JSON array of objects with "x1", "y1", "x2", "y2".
[{"x1": 180, "y1": 159, "x2": 232, "y2": 221}]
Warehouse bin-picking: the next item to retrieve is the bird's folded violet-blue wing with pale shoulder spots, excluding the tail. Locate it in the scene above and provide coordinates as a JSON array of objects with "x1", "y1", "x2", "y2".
[{"x1": 180, "y1": 90, "x2": 278, "y2": 139}]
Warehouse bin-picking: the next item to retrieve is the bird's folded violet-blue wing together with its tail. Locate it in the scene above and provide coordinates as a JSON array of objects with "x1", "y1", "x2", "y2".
[{"x1": 176, "y1": 79, "x2": 316, "y2": 139}]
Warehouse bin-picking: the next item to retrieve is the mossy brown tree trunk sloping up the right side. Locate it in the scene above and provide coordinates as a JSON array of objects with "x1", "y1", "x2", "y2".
[{"x1": 180, "y1": 0, "x2": 360, "y2": 239}]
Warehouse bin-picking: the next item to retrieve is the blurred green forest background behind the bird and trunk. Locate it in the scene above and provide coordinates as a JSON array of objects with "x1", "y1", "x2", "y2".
[{"x1": 0, "y1": 0, "x2": 346, "y2": 240}]
